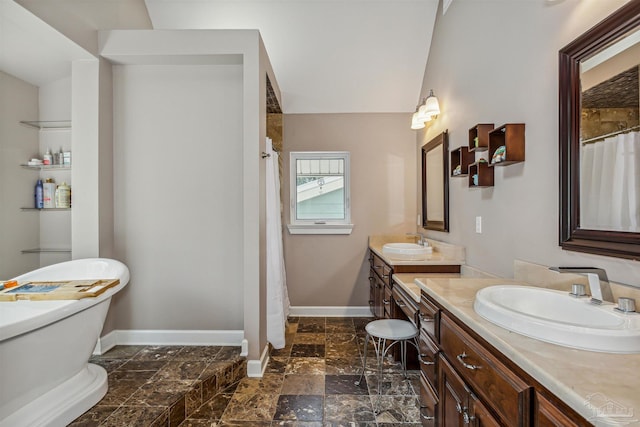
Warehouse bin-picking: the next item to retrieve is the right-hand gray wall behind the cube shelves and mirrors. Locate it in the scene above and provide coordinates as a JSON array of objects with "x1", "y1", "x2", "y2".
[{"x1": 417, "y1": 0, "x2": 640, "y2": 285}]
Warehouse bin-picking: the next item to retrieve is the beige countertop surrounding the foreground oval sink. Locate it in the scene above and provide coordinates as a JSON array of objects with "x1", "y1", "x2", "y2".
[{"x1": 394, "y1": 274, "x2": 640, "y2": 426}]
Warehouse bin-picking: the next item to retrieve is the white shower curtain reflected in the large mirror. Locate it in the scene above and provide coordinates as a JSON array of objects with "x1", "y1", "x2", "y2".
[{"x1": 580, "y1": 132, "x2": 640, "y2": 232}]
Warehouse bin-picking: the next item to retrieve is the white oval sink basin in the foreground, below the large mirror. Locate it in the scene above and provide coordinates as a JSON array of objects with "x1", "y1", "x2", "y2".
[{"x1": 473, "y1": 285, "x2": 640, "y2": 353}]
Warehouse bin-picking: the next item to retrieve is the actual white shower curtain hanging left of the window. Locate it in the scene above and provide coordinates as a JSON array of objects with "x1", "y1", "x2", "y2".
[{"x1": 266, "y1": 138, "x2": 289, "y2": 349}]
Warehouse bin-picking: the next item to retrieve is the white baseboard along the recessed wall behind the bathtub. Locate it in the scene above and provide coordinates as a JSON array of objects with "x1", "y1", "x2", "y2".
[{"x1": 93, "y1": 329, "x2": 244, "y2": 355}]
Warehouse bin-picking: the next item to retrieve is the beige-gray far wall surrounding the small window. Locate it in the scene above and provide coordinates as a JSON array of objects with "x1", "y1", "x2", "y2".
[{"x1": 282, "y1": 113, "x2": 418, "y2": 306}]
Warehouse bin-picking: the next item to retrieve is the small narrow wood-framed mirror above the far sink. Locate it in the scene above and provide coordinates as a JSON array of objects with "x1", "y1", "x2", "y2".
[{"x1": 422, "y1": 131, "x2": 449, "y2": 231}]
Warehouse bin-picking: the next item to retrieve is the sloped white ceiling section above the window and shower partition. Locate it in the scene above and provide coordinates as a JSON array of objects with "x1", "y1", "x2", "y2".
[{"x1": 145, "y1": 0, "x2": 438, "y2": 114}]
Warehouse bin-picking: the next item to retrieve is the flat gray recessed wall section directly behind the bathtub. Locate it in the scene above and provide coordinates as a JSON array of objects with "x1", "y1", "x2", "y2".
[{"x1": 110, "y1": 65, "x2": 243, "y2": 330}]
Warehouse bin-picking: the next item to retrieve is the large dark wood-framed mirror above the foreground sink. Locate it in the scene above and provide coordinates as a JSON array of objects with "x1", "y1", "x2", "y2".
[{"x1": 559, "y1": 0, "x2": 640, "y2": 259}]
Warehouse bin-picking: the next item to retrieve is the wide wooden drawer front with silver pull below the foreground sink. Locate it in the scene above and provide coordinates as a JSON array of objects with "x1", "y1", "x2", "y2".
[{"x1": 440, "y1": 314, "x2": 531, "y2": 426}]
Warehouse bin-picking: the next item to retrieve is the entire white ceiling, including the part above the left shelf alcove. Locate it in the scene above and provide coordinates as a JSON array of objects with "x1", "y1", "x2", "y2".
[{"x1": 0, "y1": 0, "x2": 440, "y2": 114}]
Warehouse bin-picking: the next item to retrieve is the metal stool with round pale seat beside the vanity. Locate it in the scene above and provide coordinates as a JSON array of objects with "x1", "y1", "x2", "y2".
[{"x1": 356, "y1": 319, "x2": 419, "y2": 395}]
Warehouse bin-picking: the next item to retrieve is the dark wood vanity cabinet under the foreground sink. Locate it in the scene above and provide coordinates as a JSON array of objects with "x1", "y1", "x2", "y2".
[{"x1": 420, "y1": 292, "x2": 590, "y2": 427}]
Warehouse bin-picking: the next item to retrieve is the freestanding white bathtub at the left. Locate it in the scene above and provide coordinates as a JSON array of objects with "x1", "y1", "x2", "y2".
[{"x1": 0, "y1": 258, "x2": 129, "y2": 427}]
